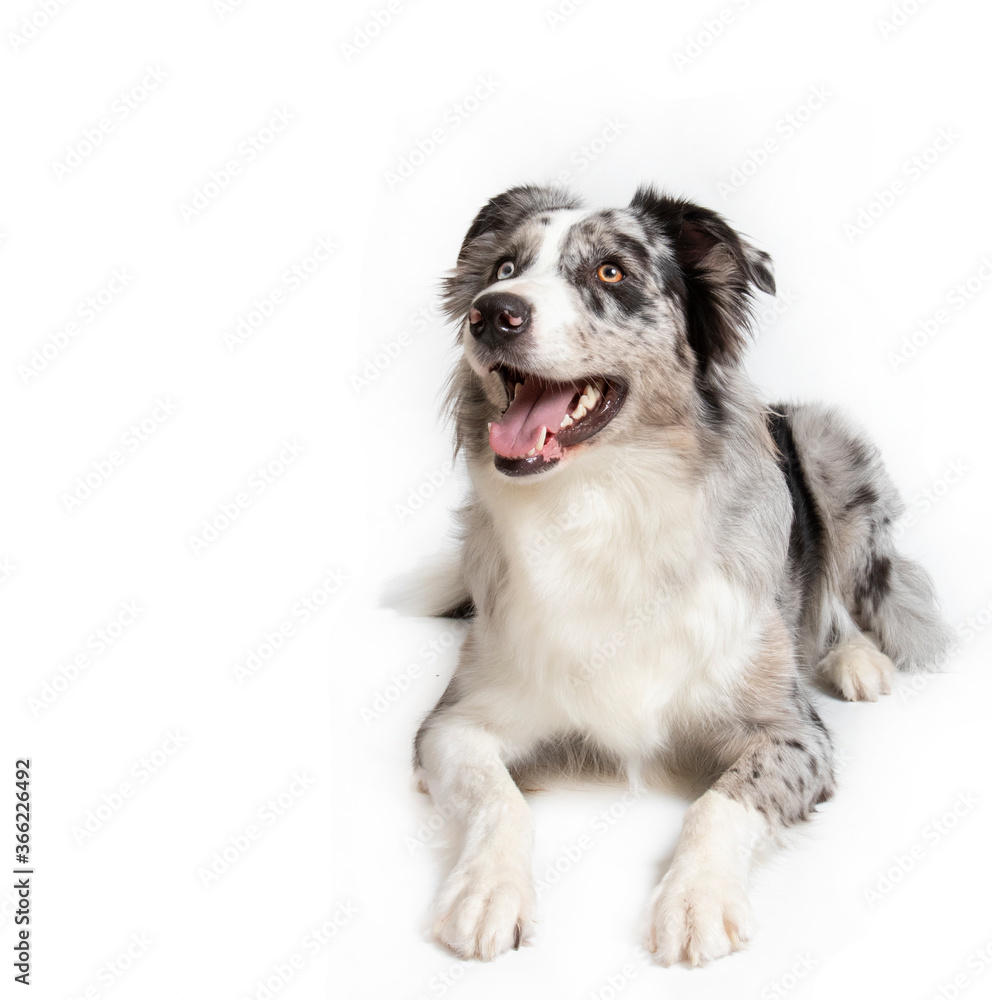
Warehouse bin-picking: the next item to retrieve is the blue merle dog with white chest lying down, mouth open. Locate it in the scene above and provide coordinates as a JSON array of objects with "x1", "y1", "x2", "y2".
[{"x1": 414, "y1": 186, "x2": 951, "y2": 965}]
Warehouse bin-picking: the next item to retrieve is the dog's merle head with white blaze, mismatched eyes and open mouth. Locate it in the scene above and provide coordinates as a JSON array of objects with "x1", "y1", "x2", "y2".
[{"x1": 445, "y1": 187, "x2": 775, "y2": 476}]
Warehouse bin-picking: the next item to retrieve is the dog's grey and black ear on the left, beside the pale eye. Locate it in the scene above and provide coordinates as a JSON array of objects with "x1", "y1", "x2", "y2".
[{"x1": 443, "y1": 184, "x2": 580, "y2": 320}]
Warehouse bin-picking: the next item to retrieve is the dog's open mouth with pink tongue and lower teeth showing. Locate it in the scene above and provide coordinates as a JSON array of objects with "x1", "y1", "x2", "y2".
[{"x1": 489, "y1": 365, "x2": 627, "y2": 476}]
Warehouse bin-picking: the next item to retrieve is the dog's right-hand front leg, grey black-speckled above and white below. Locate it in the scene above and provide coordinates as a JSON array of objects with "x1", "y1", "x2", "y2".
[{"x1": 647, "y1": 699, "x2": 833, "y2": 965}]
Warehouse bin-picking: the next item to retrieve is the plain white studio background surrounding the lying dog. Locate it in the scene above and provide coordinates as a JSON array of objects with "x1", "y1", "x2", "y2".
[{"x1": 0, "y1": 0, "x2": 992, "y2": 1000}]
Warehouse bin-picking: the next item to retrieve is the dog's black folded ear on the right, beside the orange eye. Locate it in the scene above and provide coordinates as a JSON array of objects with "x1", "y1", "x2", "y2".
[{"x1": 630, "y1": 187, "x2": 775, "y2": 371}]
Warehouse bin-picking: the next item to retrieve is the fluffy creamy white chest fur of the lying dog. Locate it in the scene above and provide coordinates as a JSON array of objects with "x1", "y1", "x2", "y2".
[{"x1": 472, "y1": 452, "x2": 756, "y2": 759}]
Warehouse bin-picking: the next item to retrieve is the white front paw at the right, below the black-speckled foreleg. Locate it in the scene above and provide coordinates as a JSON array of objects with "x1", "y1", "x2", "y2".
[{"x1": 647, "y1": 866, "x2": 751, "y2": 965}]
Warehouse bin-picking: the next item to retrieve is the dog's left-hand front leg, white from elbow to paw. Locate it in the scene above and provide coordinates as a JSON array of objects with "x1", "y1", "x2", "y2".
[{"x1": 417, "y1": 706, "x2": 535, "y2": 960}]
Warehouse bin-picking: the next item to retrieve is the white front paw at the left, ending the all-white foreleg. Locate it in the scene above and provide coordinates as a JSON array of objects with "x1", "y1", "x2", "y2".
[{"x1": 434, "y1": 857, "x2": 535, "y2": 962}]
